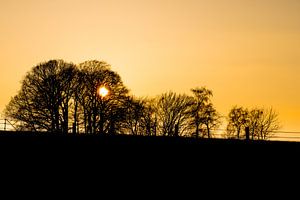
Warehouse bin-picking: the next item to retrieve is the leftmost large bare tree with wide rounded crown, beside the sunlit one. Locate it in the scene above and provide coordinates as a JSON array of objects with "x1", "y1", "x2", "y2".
[{"x1": 5, "y1": 60, "x2": 76, "y2": 133}]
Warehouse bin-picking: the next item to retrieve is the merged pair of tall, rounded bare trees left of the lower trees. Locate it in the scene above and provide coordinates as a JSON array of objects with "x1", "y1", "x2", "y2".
[{"x1": 5, "y1": 60, "x2": 128, "y2": 134}]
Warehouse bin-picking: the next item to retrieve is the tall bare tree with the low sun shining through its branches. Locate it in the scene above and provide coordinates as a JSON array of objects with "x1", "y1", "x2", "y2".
[{"x1": 78, "y1": 60, "x2": 128, "y2": 134}]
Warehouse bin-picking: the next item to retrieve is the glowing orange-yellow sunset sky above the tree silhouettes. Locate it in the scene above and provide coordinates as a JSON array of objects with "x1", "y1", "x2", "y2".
[{"x1": 0, "y1": 0, "x2": 300, "y2": 131}]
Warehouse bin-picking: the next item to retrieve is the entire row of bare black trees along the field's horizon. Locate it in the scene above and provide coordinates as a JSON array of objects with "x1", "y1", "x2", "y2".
[{"x1": 5, "y1": 60, "x2": 278, "y2": 139}]
